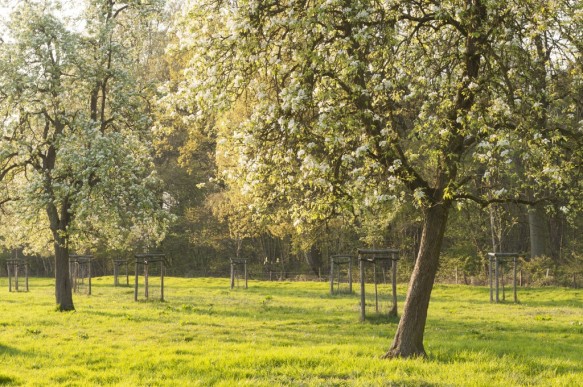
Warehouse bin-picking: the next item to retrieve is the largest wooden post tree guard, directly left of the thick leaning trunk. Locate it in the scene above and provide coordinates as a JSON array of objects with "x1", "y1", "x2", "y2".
[{"x1": 358, "y1": 249, "x2": 399, "y2": 321}]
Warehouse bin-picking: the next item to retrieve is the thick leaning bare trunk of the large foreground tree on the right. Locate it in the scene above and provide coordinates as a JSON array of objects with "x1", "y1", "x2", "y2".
[{"x1": 384, "y1": 204, "x2": 449, "y2": 358}]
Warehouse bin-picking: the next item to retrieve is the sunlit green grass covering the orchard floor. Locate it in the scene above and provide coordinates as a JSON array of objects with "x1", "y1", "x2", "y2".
[{"x1": 0, "y1": 277, "x2": 583, "y2": 386}]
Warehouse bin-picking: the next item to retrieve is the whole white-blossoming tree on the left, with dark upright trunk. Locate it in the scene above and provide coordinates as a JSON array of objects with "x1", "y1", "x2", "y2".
[{"x1": 0, "y1": 0, "x2": 170, "y2": 311}]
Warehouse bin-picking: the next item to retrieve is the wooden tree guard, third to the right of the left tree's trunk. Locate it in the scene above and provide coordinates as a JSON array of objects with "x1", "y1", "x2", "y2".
[{"x1": 134, "y1": 253, "x2": 166, "y2": 301}]
